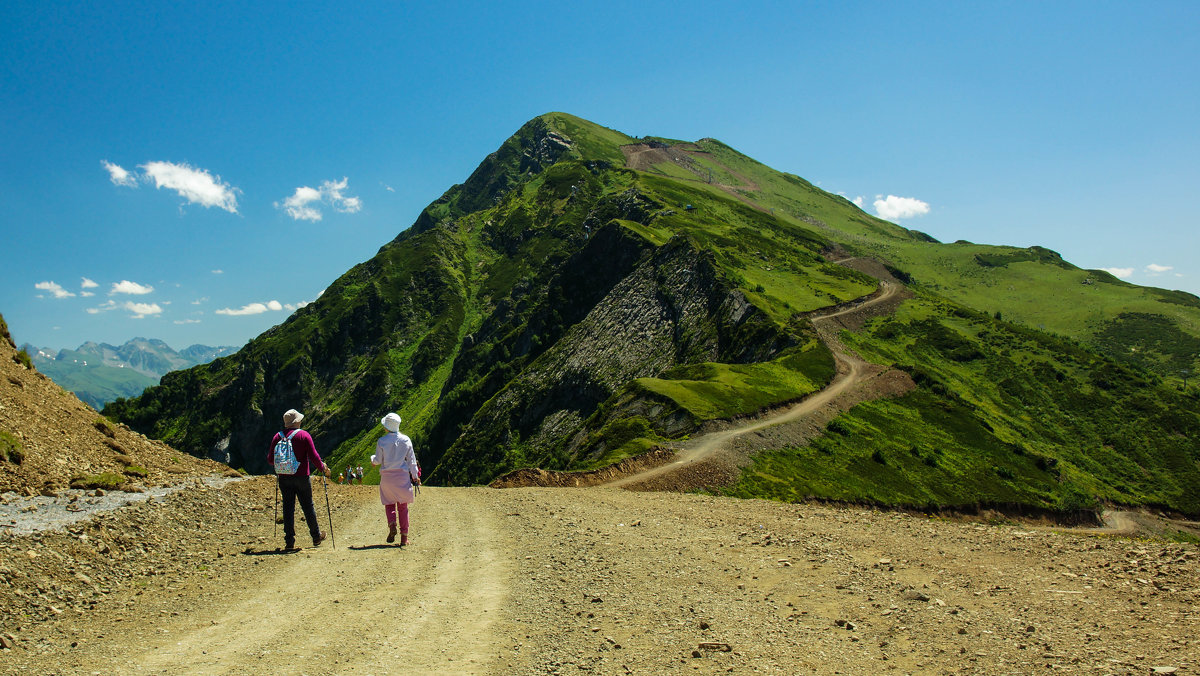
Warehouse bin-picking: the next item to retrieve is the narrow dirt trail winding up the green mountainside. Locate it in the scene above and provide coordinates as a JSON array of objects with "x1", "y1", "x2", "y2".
[{"x1": 602, "y1": 280, "x2": 904, "y2": 487}]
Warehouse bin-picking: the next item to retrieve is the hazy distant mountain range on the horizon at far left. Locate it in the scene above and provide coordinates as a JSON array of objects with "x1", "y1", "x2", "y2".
[{"x1": 22, "y1": 337, "x2": 238, "y2": 411}]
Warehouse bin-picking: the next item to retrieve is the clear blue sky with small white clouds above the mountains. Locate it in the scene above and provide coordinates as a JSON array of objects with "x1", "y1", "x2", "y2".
[{"x1": 0, "y1": 0, "x2": 1200, "y2": 348}]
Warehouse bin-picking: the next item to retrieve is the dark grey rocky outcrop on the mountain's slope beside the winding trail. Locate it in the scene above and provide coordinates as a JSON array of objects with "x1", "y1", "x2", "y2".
[{"x1": 434, "y1": 239, "x2": 793, "y2": 483}]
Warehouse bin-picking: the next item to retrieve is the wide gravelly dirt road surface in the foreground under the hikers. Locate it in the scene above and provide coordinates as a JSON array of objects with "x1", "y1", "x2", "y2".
[{"x1": 0, "y1": 478, "x2": 1200, "y2": 675}]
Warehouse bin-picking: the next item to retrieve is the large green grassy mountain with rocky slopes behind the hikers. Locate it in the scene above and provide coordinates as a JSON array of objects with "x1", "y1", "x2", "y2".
[{"x1": 104, "y1": 113, "x2": 1200, "y2": 513}]
